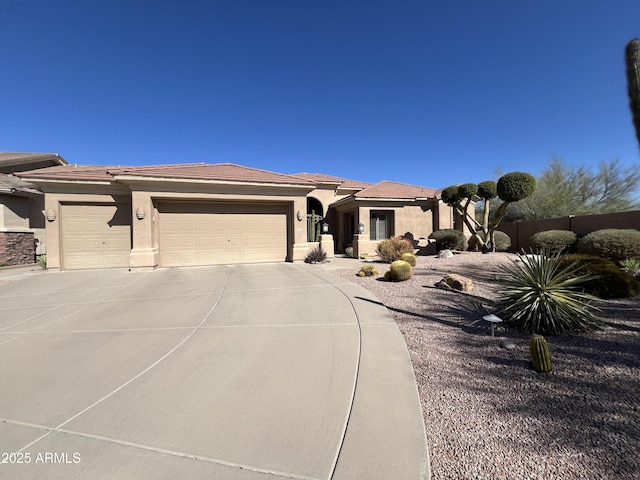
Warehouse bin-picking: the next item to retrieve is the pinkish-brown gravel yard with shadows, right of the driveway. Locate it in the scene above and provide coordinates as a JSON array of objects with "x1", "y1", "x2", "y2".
[{"x1": 332, "y1": 253, "x2": 640, "y2": 480}]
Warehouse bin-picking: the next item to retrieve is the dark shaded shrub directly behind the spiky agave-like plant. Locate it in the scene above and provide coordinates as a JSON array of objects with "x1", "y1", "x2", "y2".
[{"x1": 561, "y1": 254, "x2": 640, "y2": 299}]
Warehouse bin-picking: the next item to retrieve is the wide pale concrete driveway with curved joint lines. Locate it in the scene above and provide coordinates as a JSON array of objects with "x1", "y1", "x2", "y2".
[{"x1": 0, "y1": 264, "x2": 429, "y2": 480}]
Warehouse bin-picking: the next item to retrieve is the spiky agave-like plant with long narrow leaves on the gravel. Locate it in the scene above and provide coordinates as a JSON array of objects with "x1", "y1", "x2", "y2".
[{"x1": 498, "y1": 250, "x2": 600, "y2": 335}]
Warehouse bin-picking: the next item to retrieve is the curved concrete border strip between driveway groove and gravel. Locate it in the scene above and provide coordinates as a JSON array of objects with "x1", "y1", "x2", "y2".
[{"x1": 301, "y1": 265, "x2": 431, "y2": 480}]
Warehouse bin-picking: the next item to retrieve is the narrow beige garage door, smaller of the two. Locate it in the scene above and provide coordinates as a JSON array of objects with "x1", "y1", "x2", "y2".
[{"x1": 60, "y1": 203, "x2": 131, "y2": 270}]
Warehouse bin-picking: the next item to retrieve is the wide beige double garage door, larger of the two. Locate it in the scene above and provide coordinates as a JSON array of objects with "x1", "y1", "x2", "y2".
[{"x1": 158, "y1": 203, "x2": 287, "y2": 267}]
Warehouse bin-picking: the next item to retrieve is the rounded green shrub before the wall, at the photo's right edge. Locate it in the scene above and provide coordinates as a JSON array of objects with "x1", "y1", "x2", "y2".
[{"x1": 578, "y1": 228, "x2": 640, "y2": 262}]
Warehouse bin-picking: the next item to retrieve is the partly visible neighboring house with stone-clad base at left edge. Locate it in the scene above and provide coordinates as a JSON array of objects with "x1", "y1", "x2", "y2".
[{"x1": 0, "y1": 152, "x2": 67, "y2": 265}]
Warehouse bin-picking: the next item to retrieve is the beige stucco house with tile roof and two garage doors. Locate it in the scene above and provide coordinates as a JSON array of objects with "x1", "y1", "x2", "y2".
[{"x1": 19, "y1": 163, "x2": 464, "y2": 269}]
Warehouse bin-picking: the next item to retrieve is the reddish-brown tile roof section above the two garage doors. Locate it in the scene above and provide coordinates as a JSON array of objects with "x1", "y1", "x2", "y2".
[{"x1": 20, "y1": 163, "x2": 313, "y2": 186}]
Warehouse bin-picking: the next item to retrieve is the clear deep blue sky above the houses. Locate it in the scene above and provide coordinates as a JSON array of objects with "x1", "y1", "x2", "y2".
[{"x1": 0, "y1": 0, "x2": 640, "y2": 188}]
